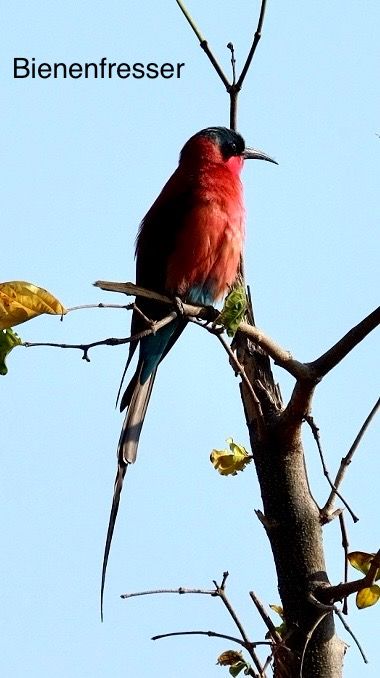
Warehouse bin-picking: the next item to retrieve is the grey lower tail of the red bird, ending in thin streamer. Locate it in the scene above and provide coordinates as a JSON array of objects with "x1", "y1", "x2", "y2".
[{"x1": 100, "y1": 361, "x2": 156, "y2": 621}]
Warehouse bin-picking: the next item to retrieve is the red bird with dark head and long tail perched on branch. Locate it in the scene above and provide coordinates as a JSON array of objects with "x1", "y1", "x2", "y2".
[{"x1": 101, "y1": 127, "x2": 275, "y2": 615}]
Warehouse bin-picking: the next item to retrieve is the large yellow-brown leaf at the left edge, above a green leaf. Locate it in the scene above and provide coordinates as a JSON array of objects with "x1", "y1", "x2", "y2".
[{"x1": 0, "y1": 280, "x2": 67, "y2": 330}]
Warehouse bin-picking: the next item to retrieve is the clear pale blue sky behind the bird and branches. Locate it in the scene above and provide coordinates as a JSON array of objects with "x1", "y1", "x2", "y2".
[{"x1": 0, "y1": 0, "x2": 380, "y2": 678}]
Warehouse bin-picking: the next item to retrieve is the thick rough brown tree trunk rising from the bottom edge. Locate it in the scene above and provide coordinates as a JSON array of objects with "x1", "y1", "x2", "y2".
[{"x1": 238, "y1": 336, "x2": 345, "y2": 678}]
